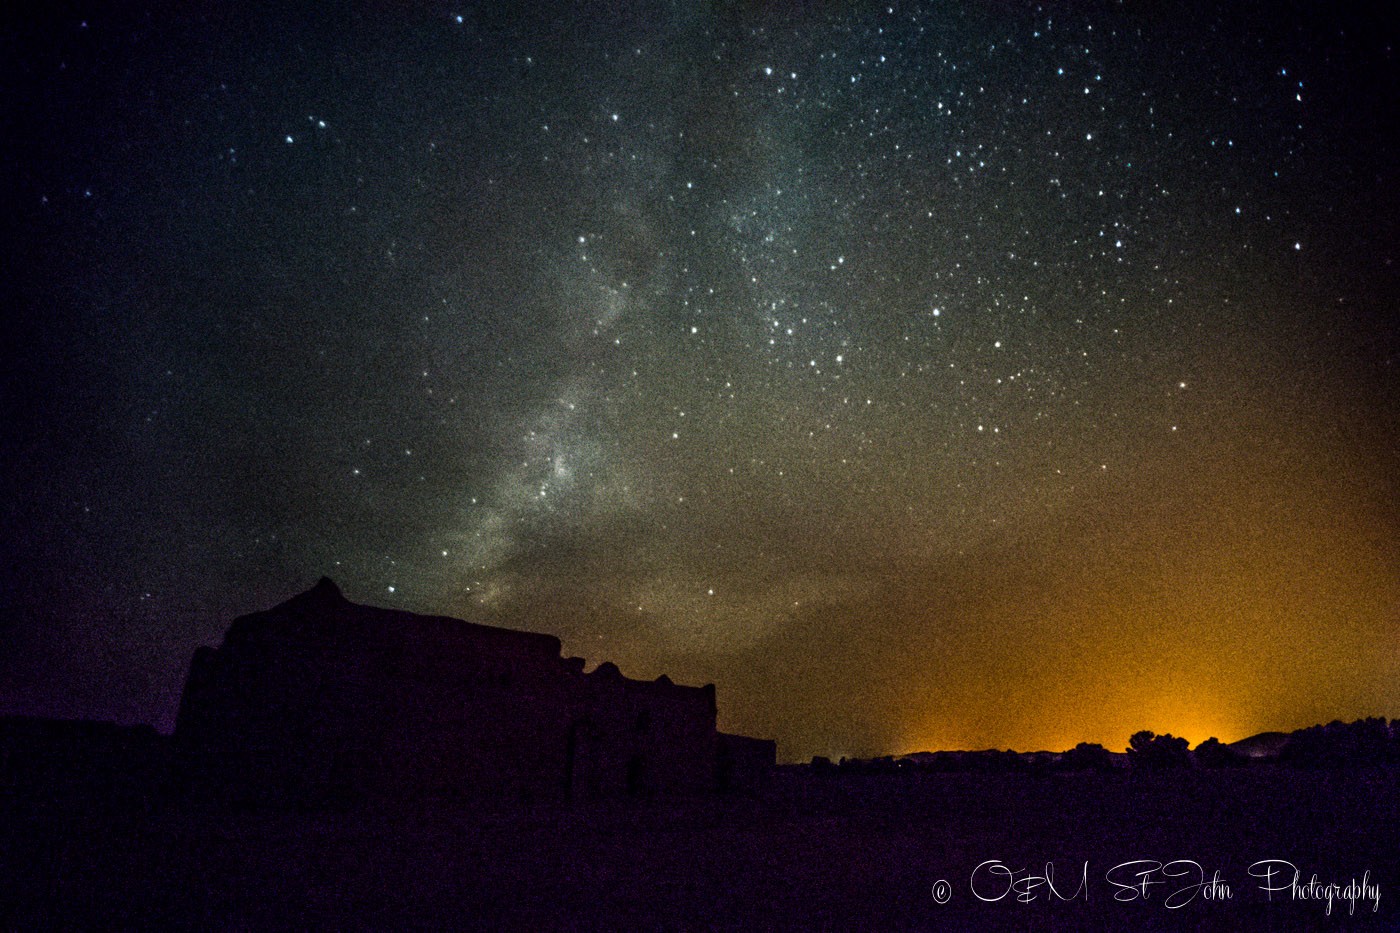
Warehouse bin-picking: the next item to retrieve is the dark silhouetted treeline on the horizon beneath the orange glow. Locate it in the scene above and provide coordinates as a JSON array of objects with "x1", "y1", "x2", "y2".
[{"x1": 811, "y1": 717, "x2": 1400, "y2": 773}]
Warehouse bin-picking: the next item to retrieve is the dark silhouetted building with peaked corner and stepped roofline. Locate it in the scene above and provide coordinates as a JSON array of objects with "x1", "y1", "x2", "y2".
[{"x1": 175, "y1": 579, "x2": 774, "y2": 803}]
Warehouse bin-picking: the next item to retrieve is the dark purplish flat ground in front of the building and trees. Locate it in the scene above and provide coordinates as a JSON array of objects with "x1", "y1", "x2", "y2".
[{"x1": 0, "y1": 768, "x2": 1400, "y2": 930}]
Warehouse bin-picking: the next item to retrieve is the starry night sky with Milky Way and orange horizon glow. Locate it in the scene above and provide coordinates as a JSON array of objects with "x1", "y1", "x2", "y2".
[{"x1": 0, "y1": 0, "x2": 1400, "y2": 759}]
